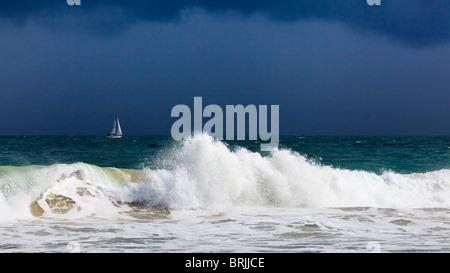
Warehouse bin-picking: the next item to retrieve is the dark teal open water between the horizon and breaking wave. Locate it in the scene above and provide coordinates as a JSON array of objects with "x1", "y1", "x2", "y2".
[{"x1": 0, "y1": 136, "x2": 450, "y2": 173}]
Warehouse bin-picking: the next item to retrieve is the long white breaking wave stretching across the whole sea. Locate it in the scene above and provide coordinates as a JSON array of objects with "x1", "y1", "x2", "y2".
[{"x1": 0, "y1": 135, "x2": 450, "y2": 221}]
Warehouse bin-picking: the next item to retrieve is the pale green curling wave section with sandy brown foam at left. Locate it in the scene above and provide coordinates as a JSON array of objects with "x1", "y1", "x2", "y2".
[{"x1": 0, "y1": 163, "x2": 139, "y2": 220}]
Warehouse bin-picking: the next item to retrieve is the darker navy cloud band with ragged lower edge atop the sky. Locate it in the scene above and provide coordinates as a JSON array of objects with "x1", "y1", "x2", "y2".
[{"x1": 0, "y1": 0, "x2": 450, "y2": 47}]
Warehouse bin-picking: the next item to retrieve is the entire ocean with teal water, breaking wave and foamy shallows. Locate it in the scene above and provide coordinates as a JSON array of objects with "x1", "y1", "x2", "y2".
[{"x1": 0, "y1": 135, "x2": 450, "y2": 253}]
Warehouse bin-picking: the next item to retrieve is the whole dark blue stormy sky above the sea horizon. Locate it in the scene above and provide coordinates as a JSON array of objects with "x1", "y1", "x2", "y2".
[{"x1": 0, "y1": 0, "x2": 450, "y2": 135}]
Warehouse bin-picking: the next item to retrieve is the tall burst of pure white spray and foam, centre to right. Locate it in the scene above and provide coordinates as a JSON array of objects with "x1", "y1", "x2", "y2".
[{"x1": 121, "y1": 135, "x2": 450, "y2": 209}]
